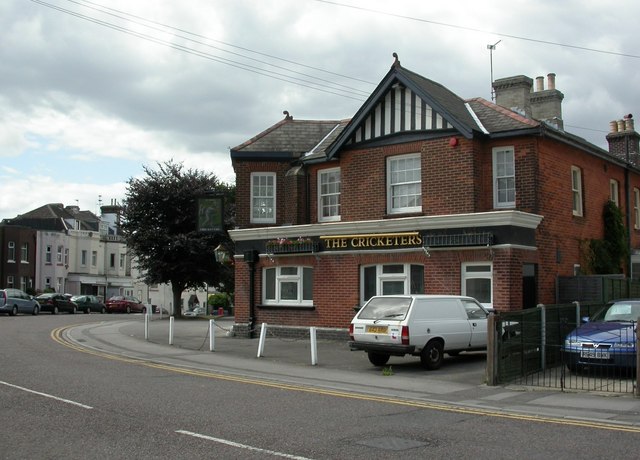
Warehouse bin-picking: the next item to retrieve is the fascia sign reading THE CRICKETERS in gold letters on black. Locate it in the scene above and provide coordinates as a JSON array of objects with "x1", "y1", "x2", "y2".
[{"x1": 320, "y1": 232, "x2": 422, "y2": 251}]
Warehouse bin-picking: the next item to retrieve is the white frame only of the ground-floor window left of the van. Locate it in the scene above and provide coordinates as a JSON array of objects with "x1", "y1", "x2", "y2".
[{"x1": 262, "y1": 265, "x2": 313, "y2": 307}]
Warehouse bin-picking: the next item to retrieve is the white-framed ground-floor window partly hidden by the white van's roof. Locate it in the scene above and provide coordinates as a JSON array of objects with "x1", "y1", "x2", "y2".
[{"x1": 360, "y1": 264, "x2": 424, "y2": 303}]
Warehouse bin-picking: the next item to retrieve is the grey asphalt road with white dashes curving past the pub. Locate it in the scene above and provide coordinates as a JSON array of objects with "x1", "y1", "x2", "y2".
[{"x1": 0, "y1": 314, "x2": 640, "y2": 460}]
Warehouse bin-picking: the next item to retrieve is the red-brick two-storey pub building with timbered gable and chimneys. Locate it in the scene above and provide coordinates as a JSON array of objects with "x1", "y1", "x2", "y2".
[{"x1": 230, "y1": 58, "x2": 640, "y2": 338}]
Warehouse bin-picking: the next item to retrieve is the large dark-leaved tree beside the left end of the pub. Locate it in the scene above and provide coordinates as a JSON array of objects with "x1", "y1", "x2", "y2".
[{"x1": 120, "y1": 160, "x2": 235, "y2": 317}]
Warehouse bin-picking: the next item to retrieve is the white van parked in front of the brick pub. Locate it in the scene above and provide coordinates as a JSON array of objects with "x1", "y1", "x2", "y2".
[{"x1": 349, "y1": 295, "x2": 490, "y2": 370}]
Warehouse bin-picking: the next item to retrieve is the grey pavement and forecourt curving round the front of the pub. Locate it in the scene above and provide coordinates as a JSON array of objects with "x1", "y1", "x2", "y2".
[{"x1": 64, "y1": 315, "x2": 640, "y2": 433}]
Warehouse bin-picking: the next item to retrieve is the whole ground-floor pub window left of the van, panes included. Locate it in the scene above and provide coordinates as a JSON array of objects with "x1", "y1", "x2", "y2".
[{"x1": 262, "y1": 266, "x2": 313, "y2": 306}]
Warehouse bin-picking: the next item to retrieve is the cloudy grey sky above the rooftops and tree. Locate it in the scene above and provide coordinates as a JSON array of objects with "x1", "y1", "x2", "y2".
[{"x1": 0, "y1": 0, "x2": 640, "y2": 219}]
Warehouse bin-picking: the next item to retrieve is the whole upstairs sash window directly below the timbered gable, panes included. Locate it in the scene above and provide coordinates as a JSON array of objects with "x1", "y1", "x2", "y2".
[{"x1": 387, "y1": 153, "x2": 422, "y2": 214}]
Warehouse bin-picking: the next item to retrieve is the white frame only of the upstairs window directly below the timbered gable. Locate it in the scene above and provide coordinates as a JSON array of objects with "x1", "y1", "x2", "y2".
[{"x1": 387, "y1": 153, "x2": 422, "y2": 214}]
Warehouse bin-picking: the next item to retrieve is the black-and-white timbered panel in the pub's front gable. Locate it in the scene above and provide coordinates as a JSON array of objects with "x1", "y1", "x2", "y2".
[{"x1": 346, "y1": 84, "x2": 451, "y2": 145}]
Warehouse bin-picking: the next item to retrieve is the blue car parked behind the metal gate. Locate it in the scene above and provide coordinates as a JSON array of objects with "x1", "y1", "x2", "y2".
[{"x1": 562, "y1": 299, "x2": 640, "y2": 371}]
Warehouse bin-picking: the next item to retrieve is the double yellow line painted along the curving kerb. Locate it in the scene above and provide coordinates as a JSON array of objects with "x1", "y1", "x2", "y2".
[{"x1": 51, "y1": 326, "x2": 640, "y2": 433}]
